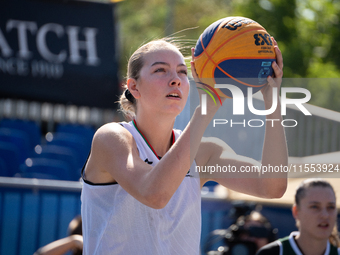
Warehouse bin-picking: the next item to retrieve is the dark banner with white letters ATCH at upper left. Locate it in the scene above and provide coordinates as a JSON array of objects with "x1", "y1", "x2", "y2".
[{"x1": 0, "y1": 0, "x2": 120, "y2": 108}]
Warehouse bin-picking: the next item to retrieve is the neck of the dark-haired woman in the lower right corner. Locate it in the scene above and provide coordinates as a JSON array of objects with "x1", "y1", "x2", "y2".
[{"x1": 295, "y1": 233, "x2": 328, "y2": 255}]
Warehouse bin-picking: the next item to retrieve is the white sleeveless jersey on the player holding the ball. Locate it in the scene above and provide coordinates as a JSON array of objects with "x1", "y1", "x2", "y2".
[{"x1": 81, "y1": 122, "x2": 201, "y2": 255}]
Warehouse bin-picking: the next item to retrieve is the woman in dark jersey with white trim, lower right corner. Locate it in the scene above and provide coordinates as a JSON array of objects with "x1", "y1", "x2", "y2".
[{"x1": 258, "y1": 179, "x2": 340, "y2": 255}]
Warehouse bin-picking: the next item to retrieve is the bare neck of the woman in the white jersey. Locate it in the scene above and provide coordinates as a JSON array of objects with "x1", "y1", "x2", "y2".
[{"x1": 135, "y1": 115, "x2": 175, "y2": 157}]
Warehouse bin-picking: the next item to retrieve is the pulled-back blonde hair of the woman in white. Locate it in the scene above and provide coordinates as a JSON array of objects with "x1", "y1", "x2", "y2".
[{"x1": 118, "y1": 38, "x2": 186, "y2": 119}]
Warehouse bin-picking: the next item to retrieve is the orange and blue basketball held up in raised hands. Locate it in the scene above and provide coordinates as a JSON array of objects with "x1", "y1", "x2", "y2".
[{"x1": 194, "y1": 17, "x2": 276, "y2": 98}]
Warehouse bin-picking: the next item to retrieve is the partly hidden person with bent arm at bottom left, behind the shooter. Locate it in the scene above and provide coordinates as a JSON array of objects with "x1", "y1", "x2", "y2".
[{"x1": 33, "y1": 215, "x2": 83, "y2": 255}]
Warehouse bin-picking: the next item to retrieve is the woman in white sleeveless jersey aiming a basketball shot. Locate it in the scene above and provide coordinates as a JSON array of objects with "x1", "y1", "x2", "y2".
[{"x1": 81, "y1": 37, "x2": 287, "y2": 255}]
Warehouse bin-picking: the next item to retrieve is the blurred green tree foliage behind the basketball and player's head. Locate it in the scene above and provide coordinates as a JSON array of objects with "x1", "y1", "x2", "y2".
[{"x1": 117, "y1": 0, "x2": 340, "y2": 111}]
